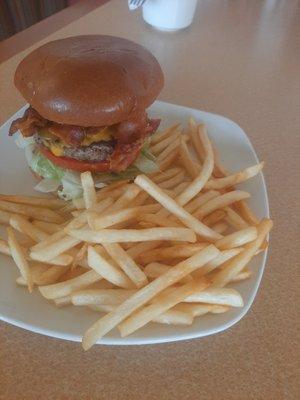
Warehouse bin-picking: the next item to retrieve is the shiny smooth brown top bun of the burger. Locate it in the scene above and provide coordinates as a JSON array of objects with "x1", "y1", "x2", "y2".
[{"x1": 15, "y1": 35, "x2": 164, "y2": 127}]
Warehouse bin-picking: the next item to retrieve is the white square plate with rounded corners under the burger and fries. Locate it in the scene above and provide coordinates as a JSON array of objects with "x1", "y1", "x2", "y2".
[{"x1": 0, "y1": 101, "x2": 269, "y2": 345}]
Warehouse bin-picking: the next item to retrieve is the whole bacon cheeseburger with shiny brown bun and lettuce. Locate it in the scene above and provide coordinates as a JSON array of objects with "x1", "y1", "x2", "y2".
[{"x1": 9, "y1": 35, "x2": 164, "y2": 199}]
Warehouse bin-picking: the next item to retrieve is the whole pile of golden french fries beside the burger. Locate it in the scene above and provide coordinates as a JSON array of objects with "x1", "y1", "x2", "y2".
[{"x1": 0, "y1": 119, "x2": 272, "y2": 350}]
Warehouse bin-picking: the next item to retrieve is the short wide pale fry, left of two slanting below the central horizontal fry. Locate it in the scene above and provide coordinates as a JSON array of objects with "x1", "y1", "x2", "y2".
[{"x1": 88, "y1": 246, "x2": 133, "y2": 289}]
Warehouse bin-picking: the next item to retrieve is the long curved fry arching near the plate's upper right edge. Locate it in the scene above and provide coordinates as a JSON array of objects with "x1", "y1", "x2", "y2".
[{"x1": 176, "y1": 128, "x2": 214, "y2": 206}]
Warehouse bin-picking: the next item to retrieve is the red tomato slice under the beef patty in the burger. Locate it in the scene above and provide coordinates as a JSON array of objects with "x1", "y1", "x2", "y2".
[{"x1": 39, "y1": 146, "x2": 110, "y2": 172}]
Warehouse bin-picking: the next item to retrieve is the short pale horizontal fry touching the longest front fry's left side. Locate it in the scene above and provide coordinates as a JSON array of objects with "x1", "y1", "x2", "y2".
[{"x1": 71, "y1": 289, "x2": 136, "y2": 306}]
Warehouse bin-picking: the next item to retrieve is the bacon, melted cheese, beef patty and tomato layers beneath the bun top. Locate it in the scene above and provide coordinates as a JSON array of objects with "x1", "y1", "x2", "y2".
[{"x1": 9, "y1": 107, "x2": 160, "y2": 172}]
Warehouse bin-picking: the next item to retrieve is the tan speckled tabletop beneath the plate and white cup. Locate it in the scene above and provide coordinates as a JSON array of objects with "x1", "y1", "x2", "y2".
[{"x1": 0, "y1": 0, "x2": 300, "y2": 400}]
